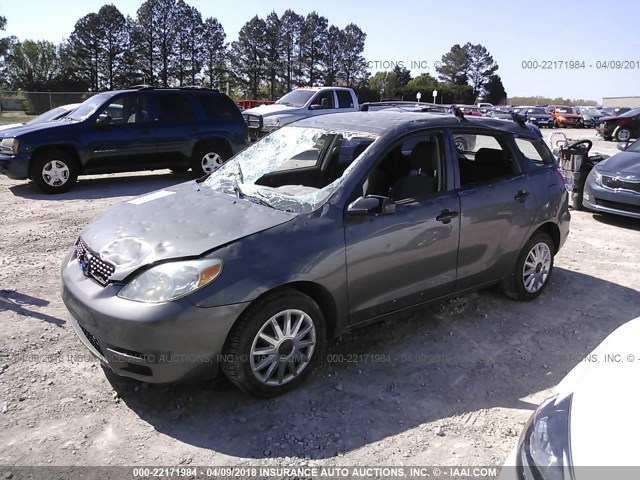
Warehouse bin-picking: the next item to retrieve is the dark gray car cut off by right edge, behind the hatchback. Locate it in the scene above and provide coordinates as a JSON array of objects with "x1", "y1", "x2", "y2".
[{"x1": 582, "y1": 140, "x2": 640, "y2": 218}]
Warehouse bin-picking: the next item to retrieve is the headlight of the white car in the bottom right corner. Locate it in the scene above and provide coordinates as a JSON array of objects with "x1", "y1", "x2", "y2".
[{"x1": 519, "y1": 395, "x2": 573, "y2": 480}]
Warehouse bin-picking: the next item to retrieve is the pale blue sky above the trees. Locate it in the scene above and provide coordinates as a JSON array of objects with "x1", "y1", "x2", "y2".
[{"x1": 0, "y1": 0, "x2": 640, "y2": 102}]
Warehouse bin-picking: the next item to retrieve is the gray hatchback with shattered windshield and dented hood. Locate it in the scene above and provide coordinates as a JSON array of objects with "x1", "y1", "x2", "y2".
[{"x1": 62, "y1": 112, "x2": 570, "y2": 396}]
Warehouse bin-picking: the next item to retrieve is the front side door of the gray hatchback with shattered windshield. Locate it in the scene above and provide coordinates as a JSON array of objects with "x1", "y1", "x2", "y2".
[{"x1": 344, "y1": 131, "x2": 460, "y2": 323}]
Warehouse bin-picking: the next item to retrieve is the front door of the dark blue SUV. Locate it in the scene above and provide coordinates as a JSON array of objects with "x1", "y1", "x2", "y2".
[{"x1": 84, "y1": 92, "x2": 156, "y2": 172}]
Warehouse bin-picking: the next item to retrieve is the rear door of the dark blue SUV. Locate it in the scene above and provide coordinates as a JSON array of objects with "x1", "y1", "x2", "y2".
[{"x1": 153, "y1": 91, "x2": 199, "y2": 166}]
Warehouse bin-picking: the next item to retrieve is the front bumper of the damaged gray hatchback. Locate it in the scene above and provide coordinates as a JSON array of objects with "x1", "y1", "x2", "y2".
[{"x1": 62, "y1": 251, "x2": 248, "y2": 383}]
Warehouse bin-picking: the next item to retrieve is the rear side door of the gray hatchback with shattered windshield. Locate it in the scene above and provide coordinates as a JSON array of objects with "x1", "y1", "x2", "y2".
[{"x1": 450, "y1": 128, "x2": 536, "y2": 290}]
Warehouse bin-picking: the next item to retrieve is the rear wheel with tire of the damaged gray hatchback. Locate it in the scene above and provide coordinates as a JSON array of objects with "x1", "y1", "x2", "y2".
[{"x1": 502, "y1": 232, "x2": 555, "y2": 301}]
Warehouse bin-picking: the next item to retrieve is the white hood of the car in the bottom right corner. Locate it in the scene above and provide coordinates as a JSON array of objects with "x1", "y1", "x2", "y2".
[{"x1": 557, "y1": 317, "x2": 640, "y2": 466}]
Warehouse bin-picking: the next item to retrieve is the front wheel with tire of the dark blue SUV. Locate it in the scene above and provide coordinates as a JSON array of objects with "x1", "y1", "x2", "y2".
[{"x1": 29, "y1": 149, "x2": 78, "y2": 194}]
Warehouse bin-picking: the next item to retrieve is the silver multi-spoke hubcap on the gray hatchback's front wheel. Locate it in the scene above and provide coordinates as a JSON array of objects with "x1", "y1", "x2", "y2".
[{"x1": 249, "y1": 309, "x2": 316, "y2": 385}]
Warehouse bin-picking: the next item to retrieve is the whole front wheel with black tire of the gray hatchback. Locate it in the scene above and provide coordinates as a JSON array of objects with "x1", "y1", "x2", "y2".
[{"x1": 222, "y1": 288, "x2": 325, "y2": 397}]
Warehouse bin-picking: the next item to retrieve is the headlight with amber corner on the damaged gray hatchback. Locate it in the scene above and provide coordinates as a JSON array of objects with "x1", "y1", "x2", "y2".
[{"x1": 118, "y1": 258, "x2": 222, "y2": 303}]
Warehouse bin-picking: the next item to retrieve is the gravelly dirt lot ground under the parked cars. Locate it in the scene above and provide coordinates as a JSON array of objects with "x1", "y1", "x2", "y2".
[{"x1": 0, "y1": 127, "x2": 640, "y2": 466}]
